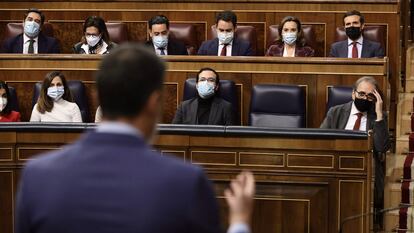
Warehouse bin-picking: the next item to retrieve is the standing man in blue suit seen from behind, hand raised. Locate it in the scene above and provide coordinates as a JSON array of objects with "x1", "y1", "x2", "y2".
[{"x1": 15, "y1": 44, "x2": 254, "y2": 233}]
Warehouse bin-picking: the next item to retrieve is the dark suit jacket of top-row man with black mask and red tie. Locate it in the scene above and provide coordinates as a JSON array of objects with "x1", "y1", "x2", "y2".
[{"x1": 329, "y1": 38, "x2": 384, "y2": 58}]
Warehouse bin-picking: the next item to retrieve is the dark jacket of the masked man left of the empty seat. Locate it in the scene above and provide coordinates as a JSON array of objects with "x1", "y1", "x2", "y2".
[{"x1": 172, "y1": 97, "x2": 233, "y2": 125}]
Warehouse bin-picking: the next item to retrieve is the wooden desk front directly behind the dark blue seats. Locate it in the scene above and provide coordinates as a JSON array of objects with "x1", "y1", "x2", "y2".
[{"x1": 0, "y1": 54, "x2": 388, "y2": 129}]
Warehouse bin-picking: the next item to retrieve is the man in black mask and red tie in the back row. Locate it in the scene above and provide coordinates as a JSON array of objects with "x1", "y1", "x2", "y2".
[{"x1": 329, "y1": 10, "x2": 384, "y2": 58}]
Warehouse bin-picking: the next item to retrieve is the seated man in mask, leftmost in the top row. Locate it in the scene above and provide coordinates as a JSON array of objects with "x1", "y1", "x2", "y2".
[{"x1": 1, "y1": 8, "x2": 60, "y2": 54}]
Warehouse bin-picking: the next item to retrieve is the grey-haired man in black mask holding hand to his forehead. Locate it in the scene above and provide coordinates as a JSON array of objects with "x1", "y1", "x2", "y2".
[{"x1": 320, "y1": 76, "x2": 390, "y2": 228}]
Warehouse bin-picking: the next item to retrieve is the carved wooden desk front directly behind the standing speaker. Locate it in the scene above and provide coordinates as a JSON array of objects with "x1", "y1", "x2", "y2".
[{"x1": 0, "y1": 123, "x2": 372, "y2": 233}]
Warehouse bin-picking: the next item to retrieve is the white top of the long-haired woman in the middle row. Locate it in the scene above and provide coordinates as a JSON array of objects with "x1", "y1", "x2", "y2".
[{"x1": 30, "y1": 98, "x2": 82, "y2": 122}]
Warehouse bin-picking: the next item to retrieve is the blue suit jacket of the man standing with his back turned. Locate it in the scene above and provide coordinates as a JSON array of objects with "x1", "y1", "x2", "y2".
[{"x1": 15, "y1": 132, "x2": 220, "y2": 233}]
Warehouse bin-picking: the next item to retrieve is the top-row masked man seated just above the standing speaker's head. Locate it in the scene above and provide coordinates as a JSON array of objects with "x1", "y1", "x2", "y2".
[{"x1": 146, "y1": 15, "x2": 188, "y2": 55}]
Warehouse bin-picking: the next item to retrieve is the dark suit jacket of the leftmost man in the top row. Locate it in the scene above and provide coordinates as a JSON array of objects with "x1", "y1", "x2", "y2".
[{"x1": 1, "y1": 33, "x2": 60, "y2": 53}]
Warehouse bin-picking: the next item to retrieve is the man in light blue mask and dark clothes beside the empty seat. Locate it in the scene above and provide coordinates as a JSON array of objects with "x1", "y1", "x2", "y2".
[{"x1": 172, "y1": 68, "x2": 234, "y2": 125}]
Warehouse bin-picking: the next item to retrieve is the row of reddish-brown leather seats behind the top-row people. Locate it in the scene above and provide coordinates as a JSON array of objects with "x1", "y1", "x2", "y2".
[{"x1": 1, "y1": 22, "x2": 387, "y2": 55}]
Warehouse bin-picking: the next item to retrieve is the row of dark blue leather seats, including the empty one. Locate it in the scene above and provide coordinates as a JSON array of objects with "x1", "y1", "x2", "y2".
[{"x1": 5, "y1": 78, "x2": 352, "y2": 125}]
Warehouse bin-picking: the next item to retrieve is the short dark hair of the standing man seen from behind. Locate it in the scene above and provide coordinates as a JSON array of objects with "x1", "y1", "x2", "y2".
[{"x1": 96, "y1": 43, "x2": 165, "y2": 120}]
